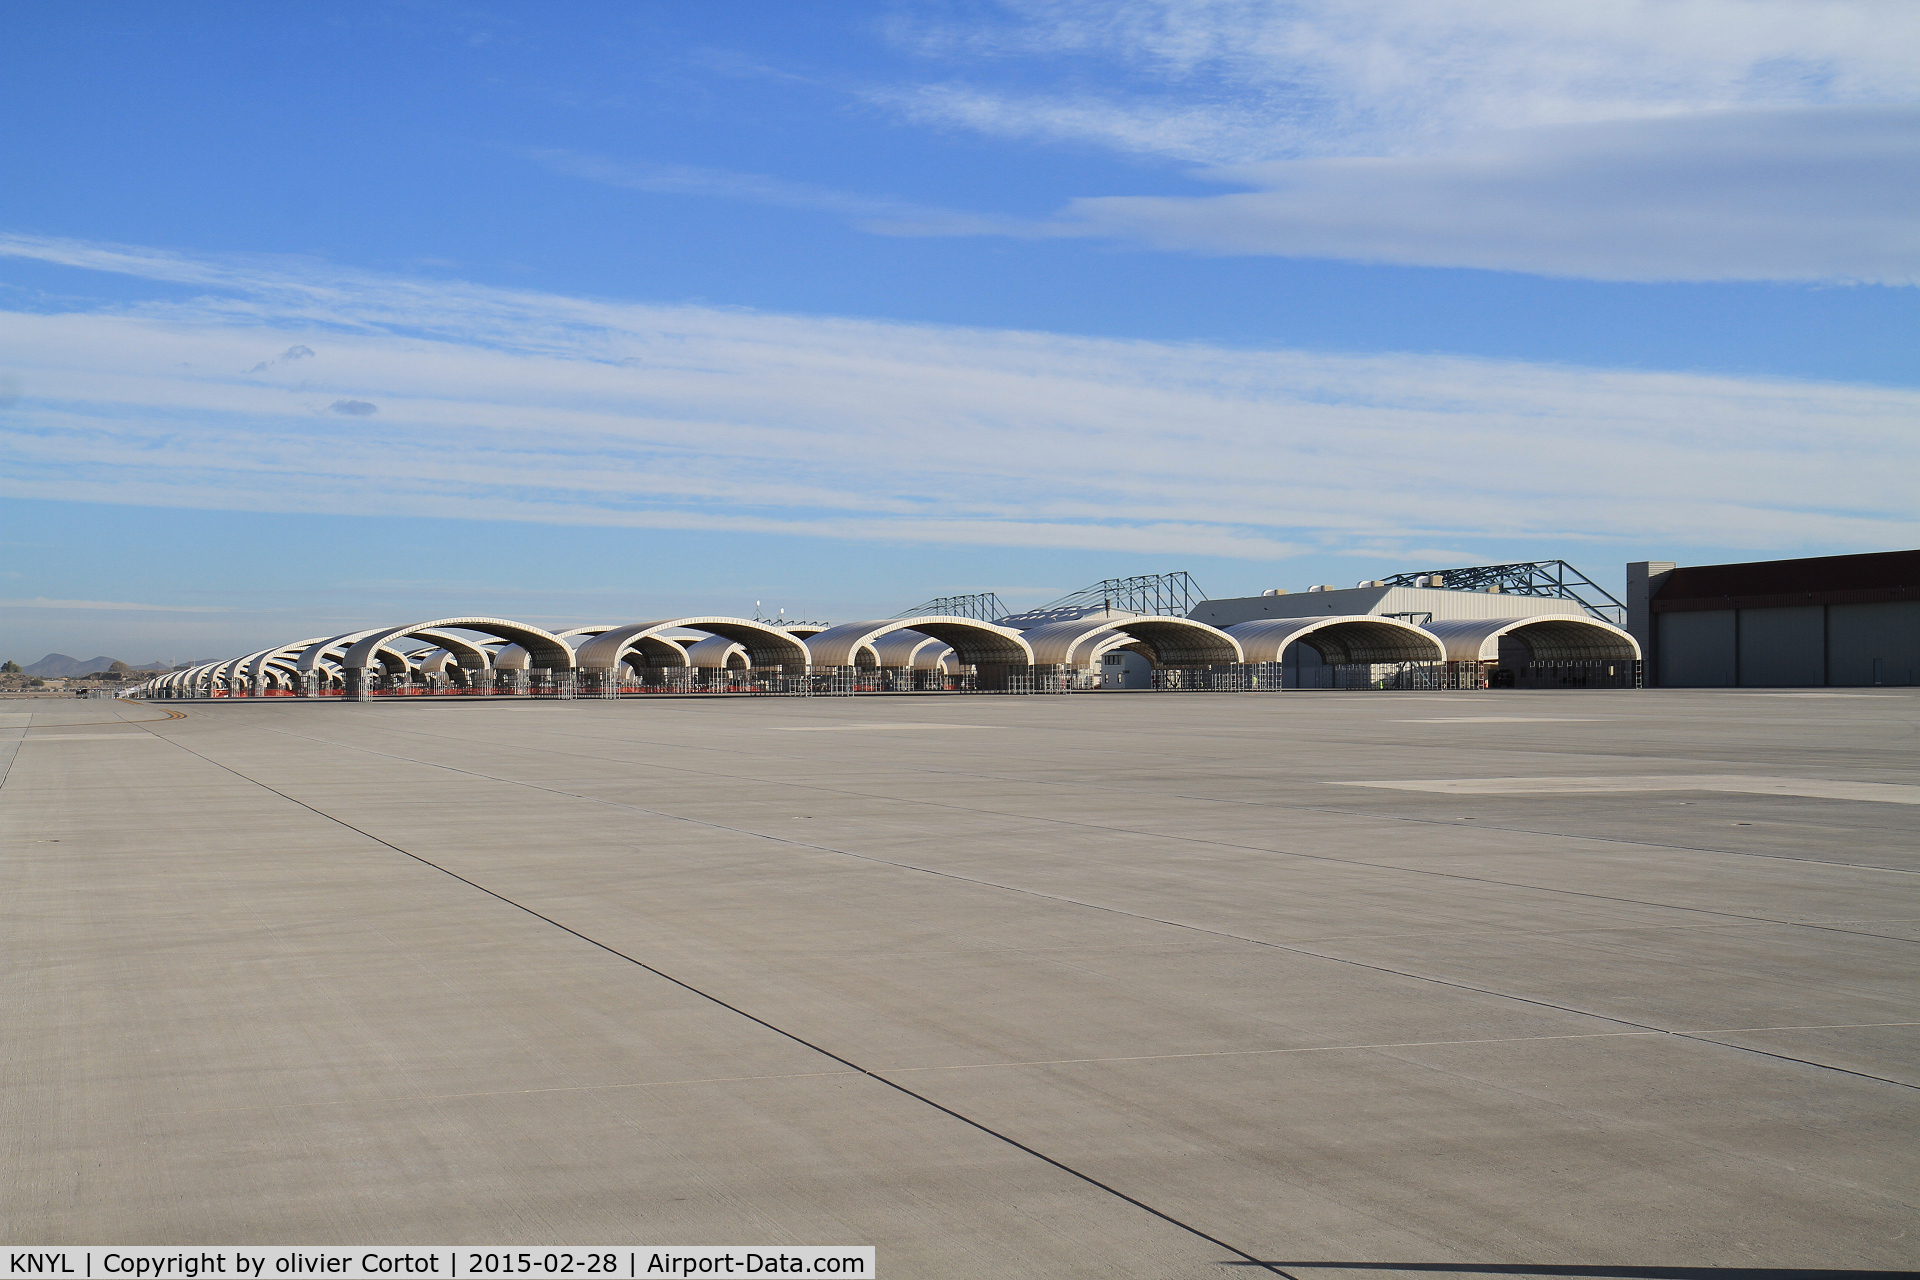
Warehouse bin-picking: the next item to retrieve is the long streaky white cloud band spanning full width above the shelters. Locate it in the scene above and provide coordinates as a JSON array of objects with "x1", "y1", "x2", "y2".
[{"x1": 0, "y1": 238, "x2": 1920, "y2": 558}]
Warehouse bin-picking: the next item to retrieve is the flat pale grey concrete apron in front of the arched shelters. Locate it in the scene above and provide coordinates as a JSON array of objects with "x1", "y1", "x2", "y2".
[{"x1": 11, "y1": 695, "x2": 1920, "y2": 1276}]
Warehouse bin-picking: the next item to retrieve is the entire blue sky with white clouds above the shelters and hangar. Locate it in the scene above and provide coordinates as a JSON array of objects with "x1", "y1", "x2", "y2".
[{"x1": 0, "y1": 0, "x2": 1920, "y2": 662}]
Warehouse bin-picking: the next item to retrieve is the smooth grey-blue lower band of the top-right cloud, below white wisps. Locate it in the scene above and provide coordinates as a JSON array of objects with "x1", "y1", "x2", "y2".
[{"x1": 877, "y1": 107, "x2": 1920, "y2": 286}]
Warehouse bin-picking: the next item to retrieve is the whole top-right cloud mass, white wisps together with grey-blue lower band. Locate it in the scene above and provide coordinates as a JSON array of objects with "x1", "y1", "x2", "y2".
[{"x1": 868, "y1": 0, "x2": 1920, "y2": 284}]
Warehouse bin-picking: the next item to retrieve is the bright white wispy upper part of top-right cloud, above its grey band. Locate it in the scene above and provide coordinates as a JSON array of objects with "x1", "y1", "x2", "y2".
[{"x1": 879, "y1": 0, "x2": 1920, "y2": 163}]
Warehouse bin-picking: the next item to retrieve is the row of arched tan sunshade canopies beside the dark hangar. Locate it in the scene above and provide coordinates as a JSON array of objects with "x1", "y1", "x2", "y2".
[{"x1": 142, "y1": 614, "x2": 1640, "y2": 695}]
